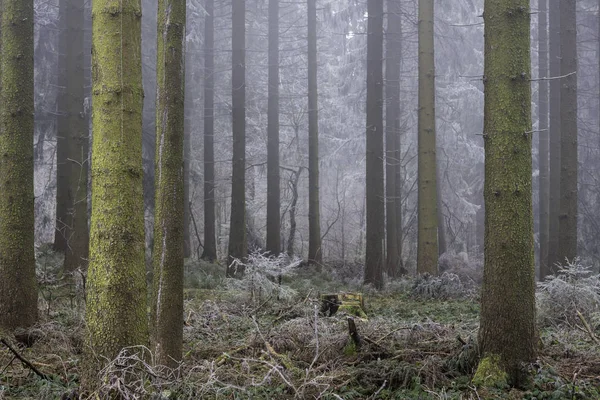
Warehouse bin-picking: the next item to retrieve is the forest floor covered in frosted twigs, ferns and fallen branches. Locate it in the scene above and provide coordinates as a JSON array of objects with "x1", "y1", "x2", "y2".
[{"x1": 0, "y1": 255, "x2": 600, "y2": 400}]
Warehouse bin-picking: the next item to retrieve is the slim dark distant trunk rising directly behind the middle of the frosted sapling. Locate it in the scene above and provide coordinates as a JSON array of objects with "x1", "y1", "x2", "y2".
[{"x1": 267, "y1": 0, "x2": 281, "y2": 256}]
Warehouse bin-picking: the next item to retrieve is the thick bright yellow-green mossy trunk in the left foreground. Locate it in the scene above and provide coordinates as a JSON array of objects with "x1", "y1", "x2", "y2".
[{"x1": 83, "y1": 0, "x2": 148, "y2": 388}]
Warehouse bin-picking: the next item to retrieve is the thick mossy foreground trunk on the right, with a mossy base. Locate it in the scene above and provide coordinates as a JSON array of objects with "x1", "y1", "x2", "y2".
[{"x1": 475, "y1": 0, "x2": 537, "y2": 385}]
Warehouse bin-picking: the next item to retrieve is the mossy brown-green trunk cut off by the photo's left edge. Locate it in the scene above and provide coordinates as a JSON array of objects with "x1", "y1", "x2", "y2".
[{"x1": 0, "y1": 0, "x2": 37, "y2": 330}]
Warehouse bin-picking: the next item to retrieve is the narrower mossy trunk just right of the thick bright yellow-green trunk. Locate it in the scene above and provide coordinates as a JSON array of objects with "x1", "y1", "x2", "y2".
[{"x1": 152, "y1": 0, "x2": 186, "y2": 367}]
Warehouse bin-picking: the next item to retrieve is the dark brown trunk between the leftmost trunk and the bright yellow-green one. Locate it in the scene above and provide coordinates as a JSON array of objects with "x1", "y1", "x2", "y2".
[{"x1": 54, "y1": 0, "x2": 89, "y2": 272}]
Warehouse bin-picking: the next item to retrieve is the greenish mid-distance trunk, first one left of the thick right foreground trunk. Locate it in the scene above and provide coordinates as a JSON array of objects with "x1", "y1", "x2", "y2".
[{"x1": 417, "y1": 0, "x2": 438, "y2": 275}]
